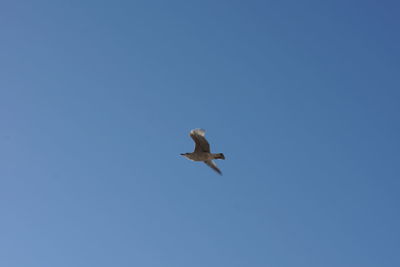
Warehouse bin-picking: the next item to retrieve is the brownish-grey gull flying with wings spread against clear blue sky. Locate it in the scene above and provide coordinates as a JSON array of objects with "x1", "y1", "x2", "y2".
[{"x1": 181, "y1": 128, "x2": 225, "y2": 175}]
